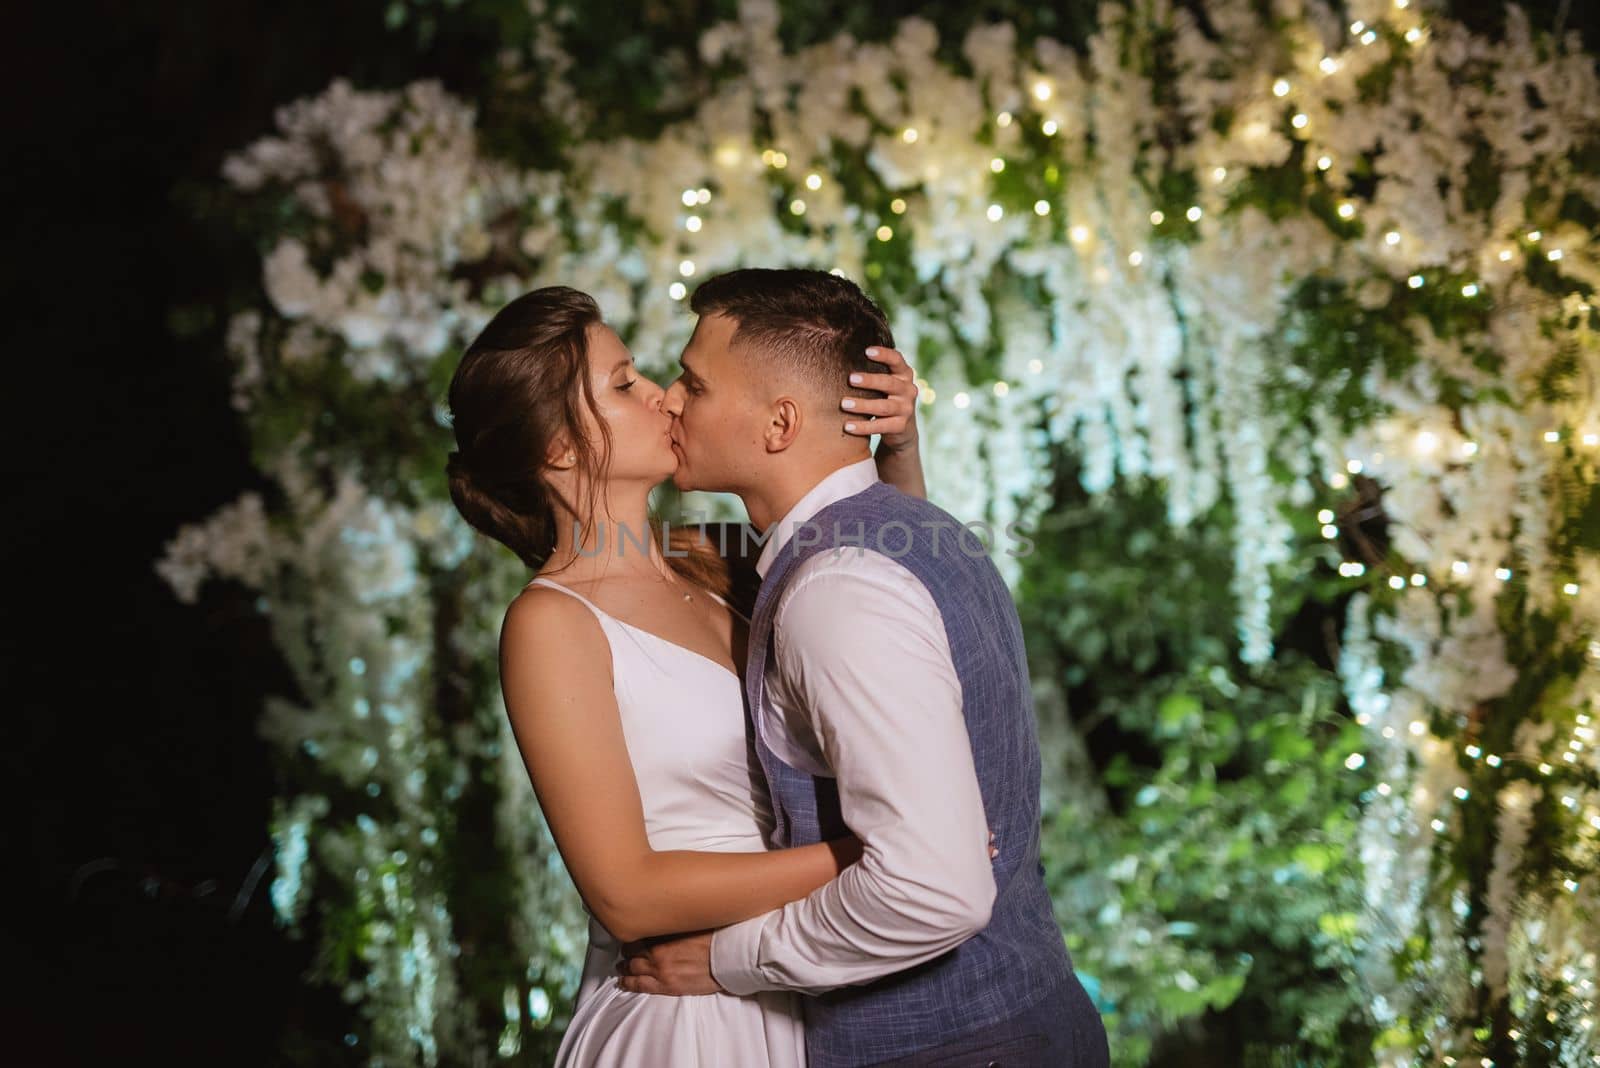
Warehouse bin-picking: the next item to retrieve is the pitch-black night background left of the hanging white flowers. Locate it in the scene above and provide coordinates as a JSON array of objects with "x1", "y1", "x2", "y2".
[{"x1": 12, "y1": 0, "x2": 1600, "y2": 1066}]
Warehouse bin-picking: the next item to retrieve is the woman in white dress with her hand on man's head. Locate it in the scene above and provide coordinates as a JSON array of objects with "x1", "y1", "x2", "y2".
[{"x1": 448, "y1": 286, "x2": 922, "y2": 1068}]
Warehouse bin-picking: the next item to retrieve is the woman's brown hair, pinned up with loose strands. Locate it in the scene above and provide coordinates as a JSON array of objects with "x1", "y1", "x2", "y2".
[{"x1": 445, "y1": 286, "x2": 730, "y2": 595}]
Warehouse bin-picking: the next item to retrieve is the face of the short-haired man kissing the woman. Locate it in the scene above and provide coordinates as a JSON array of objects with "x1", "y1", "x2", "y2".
[{"x1": 662, "y1": 308, "x2": 762, "y2": 492}]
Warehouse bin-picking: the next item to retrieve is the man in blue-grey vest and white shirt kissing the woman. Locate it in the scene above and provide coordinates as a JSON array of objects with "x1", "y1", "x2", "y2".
[{"x1": 622, "y1": 270, "x2": 1109, "y2": 1068}]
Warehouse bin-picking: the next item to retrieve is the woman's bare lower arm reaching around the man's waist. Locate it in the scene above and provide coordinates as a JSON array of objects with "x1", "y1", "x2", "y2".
[{"x1": 499, "y1": 587, "x2": 861, "y2": 942}]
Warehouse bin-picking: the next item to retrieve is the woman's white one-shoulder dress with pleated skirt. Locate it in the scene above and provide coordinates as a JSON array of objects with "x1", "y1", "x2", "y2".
[{"x1": 528, "y1": 579, "x2": 806, "y2": 1068}]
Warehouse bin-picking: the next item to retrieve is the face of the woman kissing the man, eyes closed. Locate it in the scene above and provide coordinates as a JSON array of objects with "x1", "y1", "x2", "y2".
[{"x1": 587, "y1": 323, "x2": 678, "y2": 486}]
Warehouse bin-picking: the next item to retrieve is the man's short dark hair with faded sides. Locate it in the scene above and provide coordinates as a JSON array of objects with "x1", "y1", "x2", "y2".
[{"x1": 690, "y1": 267, "x2": 894, "y2": 397}]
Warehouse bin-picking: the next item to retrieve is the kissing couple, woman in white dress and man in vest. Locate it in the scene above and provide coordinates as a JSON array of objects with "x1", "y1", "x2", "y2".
[{"x1": 448, "y1": 269, "x2": 1109, "y2": 1068}]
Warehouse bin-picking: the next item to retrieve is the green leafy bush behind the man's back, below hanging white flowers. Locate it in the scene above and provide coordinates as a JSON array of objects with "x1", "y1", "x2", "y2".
[{"x1": 1019, "y1": 467, "x2": 1371, "y2": 1065}]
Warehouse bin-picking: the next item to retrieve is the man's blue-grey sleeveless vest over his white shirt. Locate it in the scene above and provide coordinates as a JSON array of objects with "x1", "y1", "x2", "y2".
[{"x1": 746, "y1": 481, "x2": 1072, "y2": 1068}]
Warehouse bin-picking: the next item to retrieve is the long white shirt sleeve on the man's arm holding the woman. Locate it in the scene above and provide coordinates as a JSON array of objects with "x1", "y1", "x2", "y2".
[{"x1": 712, "y1": 550, "x2": 995, "y2": 994}]
